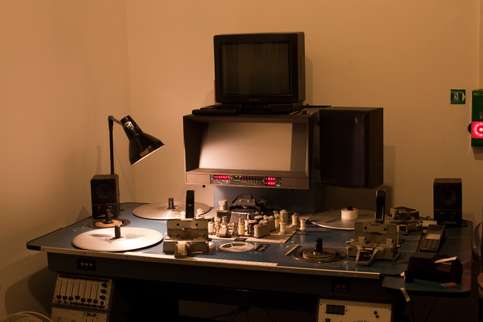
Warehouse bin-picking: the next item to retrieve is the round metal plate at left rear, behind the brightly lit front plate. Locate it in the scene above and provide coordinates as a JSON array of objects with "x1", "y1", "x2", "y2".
[{"x1": 133, "y1": 202, "x2": 211, "y2": 220}]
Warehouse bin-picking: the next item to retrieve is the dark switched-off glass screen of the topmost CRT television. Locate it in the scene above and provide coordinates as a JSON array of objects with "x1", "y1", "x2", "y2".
[{"x1": 221, "y1": 42, "x2": 291, "y2": 96}]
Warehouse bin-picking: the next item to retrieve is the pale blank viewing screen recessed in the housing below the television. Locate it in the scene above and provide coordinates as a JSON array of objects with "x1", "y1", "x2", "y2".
[{"x1": 199, "y1": 122, "x2": 294, "y2": 171}]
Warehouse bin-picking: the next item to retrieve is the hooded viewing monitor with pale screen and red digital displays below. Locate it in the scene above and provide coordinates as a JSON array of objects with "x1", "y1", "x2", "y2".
[{"x1": 183, "y1": 111, "x2": 318, "y2": 189}]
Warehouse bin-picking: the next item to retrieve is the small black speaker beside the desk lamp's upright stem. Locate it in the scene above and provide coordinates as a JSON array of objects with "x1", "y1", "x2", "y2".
[{"x1": 91, "y1": 174, "x2": 119, "y2": 218}]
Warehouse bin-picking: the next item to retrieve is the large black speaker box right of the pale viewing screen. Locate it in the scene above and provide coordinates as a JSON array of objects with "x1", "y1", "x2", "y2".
[{"x1": 319, "y1": 107, "x2": 384, "y2": 188}]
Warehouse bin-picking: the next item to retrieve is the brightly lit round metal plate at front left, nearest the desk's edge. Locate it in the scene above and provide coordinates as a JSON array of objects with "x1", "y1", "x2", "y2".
[{"x1": 72, "y1": 227, "x2": 163, "y2": 252}]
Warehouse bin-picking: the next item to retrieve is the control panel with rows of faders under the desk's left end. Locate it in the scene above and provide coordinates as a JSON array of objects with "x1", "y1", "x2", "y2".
[{"x1": 52, "y1": 275, "x2": 112, "y2": 322}]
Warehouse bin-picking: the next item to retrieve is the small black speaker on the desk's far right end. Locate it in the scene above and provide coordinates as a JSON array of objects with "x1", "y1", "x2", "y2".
[{"x1": 433, "y1": 178, "x2": 463, "y2": 226}]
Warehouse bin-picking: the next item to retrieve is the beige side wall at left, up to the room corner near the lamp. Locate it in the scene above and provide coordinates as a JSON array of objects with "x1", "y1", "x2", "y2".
[{"x1": 0, "y1": 0, "x2": 129, "y2": 319}]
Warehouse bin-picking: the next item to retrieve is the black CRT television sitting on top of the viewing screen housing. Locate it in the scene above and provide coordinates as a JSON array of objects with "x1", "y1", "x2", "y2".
[{"x1": 214, "y1": 32, "x2": 305, "y2": 105}]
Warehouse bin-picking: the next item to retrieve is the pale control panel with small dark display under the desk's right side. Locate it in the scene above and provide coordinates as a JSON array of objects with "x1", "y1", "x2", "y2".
[{"x1": 317, "y1": 299, "x2": 391, "y2": 322}]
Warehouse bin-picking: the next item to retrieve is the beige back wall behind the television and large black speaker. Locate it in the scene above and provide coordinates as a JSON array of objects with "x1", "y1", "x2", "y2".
[{"x1": 126, "y1": 0, "x2": 483, "y2": 224}]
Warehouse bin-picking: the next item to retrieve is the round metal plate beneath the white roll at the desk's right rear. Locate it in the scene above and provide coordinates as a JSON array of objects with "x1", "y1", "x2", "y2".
[{"x1": 308, "y1": 209, "x2": 376, "y2": 230}]
